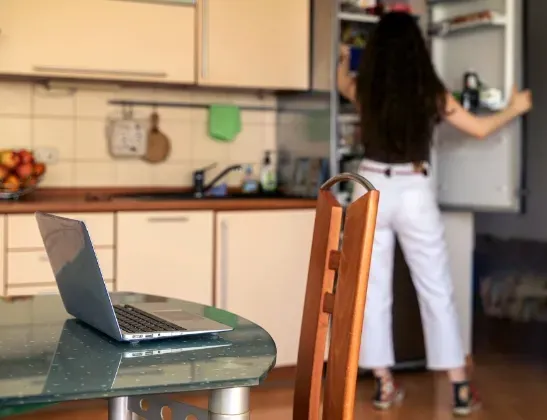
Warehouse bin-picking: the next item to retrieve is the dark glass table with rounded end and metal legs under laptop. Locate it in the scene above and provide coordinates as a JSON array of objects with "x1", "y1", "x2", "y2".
[{"x1": 0, "y1": 293, "x2": 276, "y2": 420}]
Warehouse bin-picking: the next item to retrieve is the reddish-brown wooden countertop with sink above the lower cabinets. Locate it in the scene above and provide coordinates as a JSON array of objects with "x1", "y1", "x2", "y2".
[{"x1": 0, "y1": 188, "x2": 316, "y2": 214}]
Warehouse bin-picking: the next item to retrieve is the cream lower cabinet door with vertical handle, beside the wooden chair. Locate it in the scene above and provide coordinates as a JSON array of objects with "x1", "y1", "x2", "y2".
[{"x1": 215, "y1": 210, "x2": 315, "y2": 366}]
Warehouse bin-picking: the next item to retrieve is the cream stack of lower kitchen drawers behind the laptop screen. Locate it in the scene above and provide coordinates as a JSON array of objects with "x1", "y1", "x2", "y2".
[{"x1": 2, "y1": 213, "x2": 114, "y2": 296}]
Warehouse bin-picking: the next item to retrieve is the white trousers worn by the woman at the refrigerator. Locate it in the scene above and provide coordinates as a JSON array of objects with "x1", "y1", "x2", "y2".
[{"x1": 354, "y1": 160, "x2": 464, "y2": 370}]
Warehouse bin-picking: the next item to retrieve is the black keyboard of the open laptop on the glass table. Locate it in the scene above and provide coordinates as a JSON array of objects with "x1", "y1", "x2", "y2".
[{"x1": 114, "y1": 305, "x2": 186, "y2": 334}]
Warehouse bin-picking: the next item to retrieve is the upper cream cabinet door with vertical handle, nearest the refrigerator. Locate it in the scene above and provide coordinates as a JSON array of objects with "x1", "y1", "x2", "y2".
[{"x1": 198, "y1": 0, "x2": 310, "y2": 90}]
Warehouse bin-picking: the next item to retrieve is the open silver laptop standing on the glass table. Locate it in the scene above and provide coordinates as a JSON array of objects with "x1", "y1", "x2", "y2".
[{"x1": 36, "y1": 212, "x2": 233, "y2": 342}]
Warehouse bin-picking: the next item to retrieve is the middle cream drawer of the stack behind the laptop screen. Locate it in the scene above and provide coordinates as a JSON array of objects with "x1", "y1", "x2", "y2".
[{"x1": 6, "y1": 249, "x2": 114, "y2": 289}]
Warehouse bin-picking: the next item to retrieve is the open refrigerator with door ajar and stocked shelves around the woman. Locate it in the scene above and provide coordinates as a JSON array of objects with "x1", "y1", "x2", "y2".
[{"x1": 331, "y1": 0, "x2": 524, "y2": 212}]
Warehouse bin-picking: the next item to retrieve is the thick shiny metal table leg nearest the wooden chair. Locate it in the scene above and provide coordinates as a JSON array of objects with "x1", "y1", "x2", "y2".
[{"x1": 209, "y1": 388, "x2": 250, "y2": 420}]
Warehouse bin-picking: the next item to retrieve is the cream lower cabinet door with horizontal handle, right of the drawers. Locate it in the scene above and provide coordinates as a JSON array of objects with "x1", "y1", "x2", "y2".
[{"x1": 116, "y1": 211, "x2": 214, "y2": 305}]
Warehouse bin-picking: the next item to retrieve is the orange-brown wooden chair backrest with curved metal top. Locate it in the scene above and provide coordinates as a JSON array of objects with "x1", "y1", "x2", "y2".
[{"x1": 293, "y1": 173, "x2": 379, "y2": 420}]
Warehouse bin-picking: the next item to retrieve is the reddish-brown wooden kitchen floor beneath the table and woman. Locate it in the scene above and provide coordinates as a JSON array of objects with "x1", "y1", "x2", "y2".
[{"x1": 10, "y1": 314, "x2": 547, "y2": 420}]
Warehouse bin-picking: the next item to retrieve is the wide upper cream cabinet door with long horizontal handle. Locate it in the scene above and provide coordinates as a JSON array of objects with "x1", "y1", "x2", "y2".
[{"x1": 0, "y1": 0, "x2": 195, "y2": 83}]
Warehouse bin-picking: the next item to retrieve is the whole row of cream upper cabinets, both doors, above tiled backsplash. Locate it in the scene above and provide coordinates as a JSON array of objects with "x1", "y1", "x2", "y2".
[{"x1": 0, "y1": 0, "x2": 311, "y2": 90}]
